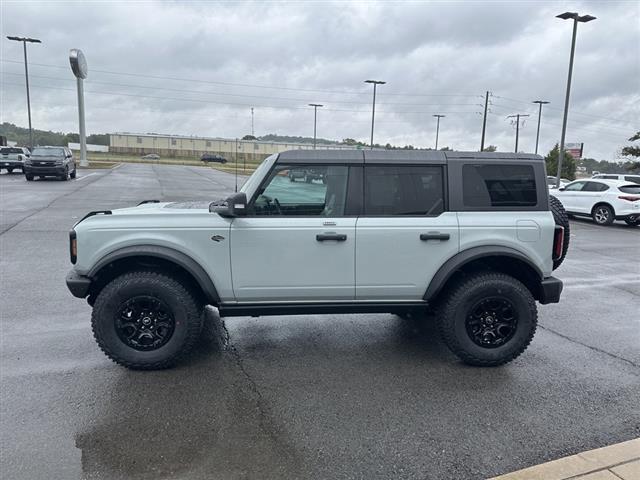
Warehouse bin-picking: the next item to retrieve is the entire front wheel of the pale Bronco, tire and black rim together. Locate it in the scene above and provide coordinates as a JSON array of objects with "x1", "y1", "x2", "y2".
[{"x1": 91, "y1": 271, "x2": 202, "y2": 370}]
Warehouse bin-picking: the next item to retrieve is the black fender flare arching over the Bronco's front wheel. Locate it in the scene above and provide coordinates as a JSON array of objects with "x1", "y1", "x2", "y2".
[{"x1": 87, "y1": 245, "x2": 220, "y2": 305}]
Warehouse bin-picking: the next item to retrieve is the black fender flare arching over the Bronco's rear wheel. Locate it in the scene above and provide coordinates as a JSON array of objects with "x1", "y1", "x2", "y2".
[{"x1": 422, "y1": 245, "x2": 544, "y2": 301}]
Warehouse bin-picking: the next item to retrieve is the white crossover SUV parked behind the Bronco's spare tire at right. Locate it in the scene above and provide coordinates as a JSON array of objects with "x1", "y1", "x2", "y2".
[{"x1": 553, "y1": 178, "x2": 640, "y2": 225}]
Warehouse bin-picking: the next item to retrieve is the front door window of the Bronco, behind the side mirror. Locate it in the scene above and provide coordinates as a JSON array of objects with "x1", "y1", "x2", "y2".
[{"x1": 250, "y1": 165, "x2": 349, "y2": 217}]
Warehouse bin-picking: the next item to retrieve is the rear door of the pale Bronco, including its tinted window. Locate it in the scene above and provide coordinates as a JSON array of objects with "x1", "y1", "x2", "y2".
[{"x1": 356, "y1": 164, "x2": 458, "y2": 300}]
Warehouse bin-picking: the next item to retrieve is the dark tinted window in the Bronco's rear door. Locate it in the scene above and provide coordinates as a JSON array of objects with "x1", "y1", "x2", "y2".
[{"x1": 364, "y1": 165, "x2": 444, "y2": 217}]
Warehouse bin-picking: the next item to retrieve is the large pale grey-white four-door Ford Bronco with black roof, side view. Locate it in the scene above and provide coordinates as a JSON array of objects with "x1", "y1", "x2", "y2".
[{"x1": 66, "y1": 150, "x2": 569, "y2": 369}]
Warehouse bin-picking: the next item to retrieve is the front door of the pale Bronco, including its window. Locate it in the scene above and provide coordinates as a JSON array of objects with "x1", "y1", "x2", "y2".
[{"x1": 231, "y1": 164, "x2": 356, "y2": 302}]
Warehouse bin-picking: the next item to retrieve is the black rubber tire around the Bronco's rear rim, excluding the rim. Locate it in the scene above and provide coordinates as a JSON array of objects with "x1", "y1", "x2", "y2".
[{"x1": 436, "y1": 272, "x2": 538, "y2": 367}]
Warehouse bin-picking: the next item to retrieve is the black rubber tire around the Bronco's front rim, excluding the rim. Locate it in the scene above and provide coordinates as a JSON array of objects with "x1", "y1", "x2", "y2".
[{"x1": 91, "y1": 271, "x2": 203, "y2": 370}]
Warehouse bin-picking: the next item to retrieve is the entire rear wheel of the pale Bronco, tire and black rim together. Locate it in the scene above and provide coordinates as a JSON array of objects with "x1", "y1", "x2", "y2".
[{"x1": 437, "y1": 273, "x2": 538, "y2": 367}]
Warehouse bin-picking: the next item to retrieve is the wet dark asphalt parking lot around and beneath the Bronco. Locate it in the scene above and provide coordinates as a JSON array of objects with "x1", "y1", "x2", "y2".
[{"x1": 0, "y1": 164, "x2": 640, "y2": 479}]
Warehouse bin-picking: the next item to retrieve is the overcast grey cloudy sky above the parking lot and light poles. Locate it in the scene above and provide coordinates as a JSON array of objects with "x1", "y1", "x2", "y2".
[{"x1": 0, "y1": 0, "x2": 640, "y2": 159}]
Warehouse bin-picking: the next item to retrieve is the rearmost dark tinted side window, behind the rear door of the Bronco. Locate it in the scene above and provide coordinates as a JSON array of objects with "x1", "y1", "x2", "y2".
[{"x1": 462, "y1": 165, "x2": 538, "y2": 207}]
